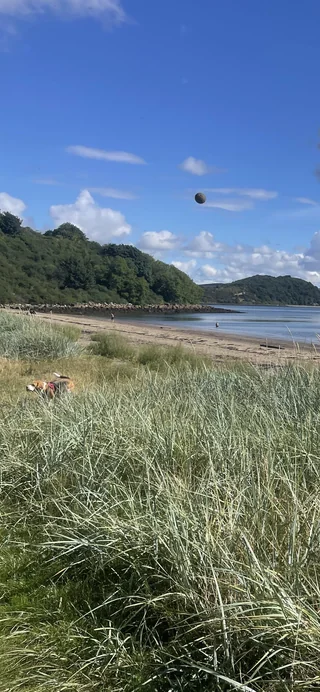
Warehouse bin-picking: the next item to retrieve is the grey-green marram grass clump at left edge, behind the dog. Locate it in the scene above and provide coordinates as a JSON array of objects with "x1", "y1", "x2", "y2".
[{"x1": 0, "y1": 312, "x2": 80, "y2": 360}]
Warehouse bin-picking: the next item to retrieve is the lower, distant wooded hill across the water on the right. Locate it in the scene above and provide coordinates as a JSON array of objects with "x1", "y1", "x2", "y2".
[{"x1": 202, "y1": 274, "x2": 320, "y2": 305}]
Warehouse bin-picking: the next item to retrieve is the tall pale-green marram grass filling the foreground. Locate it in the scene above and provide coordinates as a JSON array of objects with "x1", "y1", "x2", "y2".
[{"x1": 0, "y1": 368, "x2": 320, "y2": 692}]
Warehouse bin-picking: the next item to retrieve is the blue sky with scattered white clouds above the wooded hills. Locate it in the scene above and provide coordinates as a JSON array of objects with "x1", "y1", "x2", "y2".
[{"x1": 0, "y1": 0, "x2": 320, "y2": 284}]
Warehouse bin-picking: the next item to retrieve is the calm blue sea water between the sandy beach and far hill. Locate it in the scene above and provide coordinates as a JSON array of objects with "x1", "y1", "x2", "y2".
[{"x1": 119, "y1": 305, "x2": 320, "y2": 343}]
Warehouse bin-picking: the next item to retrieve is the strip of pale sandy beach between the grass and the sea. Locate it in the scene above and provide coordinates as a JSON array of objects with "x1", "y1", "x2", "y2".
[{"x1": 39, "y1": 314, "x2": 320, "y2": 365}]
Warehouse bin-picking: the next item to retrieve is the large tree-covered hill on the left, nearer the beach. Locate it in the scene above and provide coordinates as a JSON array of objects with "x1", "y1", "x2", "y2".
[{"x1": 0, "y1": 212, "x2": 202, "y2": 305}]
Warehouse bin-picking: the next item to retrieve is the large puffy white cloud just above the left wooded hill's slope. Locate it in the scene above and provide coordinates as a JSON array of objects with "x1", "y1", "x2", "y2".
[{"x1": 50, "y1": 190, "x2": 131, "y2": 243}]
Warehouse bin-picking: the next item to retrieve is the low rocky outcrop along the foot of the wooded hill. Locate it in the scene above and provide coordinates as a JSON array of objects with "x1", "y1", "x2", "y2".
[{"x1": 0, "y1": 303, "x2": 239, "y2": 316}]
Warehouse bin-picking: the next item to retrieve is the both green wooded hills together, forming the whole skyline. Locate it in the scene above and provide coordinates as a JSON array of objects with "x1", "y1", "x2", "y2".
[{"x1": 0, "y1": 212, "x2": 320, "y2": 309}]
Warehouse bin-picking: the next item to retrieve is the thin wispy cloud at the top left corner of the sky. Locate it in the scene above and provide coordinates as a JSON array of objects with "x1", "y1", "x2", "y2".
[{"x1": 0, "y1": 0, "x2": 126, "y2": 25}]
